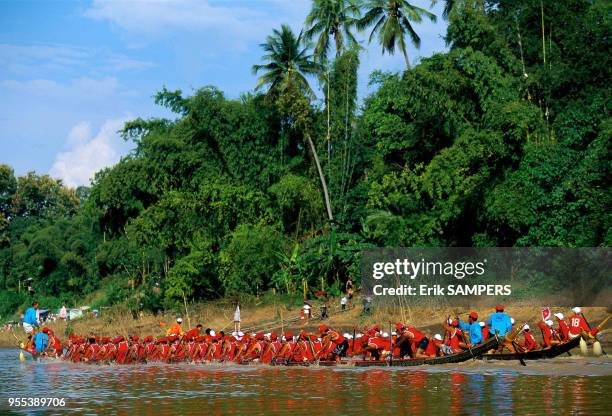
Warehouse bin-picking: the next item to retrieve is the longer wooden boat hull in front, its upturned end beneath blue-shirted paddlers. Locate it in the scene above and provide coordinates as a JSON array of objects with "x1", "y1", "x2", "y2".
[{"x1": 270, "y1": 337, "x2": 498, "y2": 367}]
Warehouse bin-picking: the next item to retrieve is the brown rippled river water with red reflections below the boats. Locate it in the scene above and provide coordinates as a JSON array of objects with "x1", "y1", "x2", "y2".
[{"x1": 0, "y1": 349, "x2": 612, "y2": 415}]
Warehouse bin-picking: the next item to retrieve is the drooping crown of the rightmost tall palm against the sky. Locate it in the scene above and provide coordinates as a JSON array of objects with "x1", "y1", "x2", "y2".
[{"x1": 357, "y1": 0, "x2": 436, "y2": 68}]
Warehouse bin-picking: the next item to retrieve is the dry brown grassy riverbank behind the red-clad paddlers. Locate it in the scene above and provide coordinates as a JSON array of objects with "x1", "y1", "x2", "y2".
[{"x1": 0, "y1": 298, "x2": 610, "y2": 347}]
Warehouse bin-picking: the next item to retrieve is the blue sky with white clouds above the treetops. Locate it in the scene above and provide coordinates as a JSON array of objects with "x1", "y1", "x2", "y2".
[{"x1": 0, "y1": 0, "x2": 446, "y2": 187}]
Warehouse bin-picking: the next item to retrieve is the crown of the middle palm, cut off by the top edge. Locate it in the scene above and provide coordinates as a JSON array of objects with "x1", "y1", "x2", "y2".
[{"x1": 304, "y1": 0, "x2": 359, "y2": 61}]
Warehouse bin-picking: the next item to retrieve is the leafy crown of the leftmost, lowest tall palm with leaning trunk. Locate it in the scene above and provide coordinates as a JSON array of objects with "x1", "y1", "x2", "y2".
[{"x1": 253, "y1": 24, "x2": 321, "y2": 97}]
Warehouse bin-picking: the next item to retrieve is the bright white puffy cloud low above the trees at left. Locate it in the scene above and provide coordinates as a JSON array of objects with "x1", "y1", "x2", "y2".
[{"x1": 49, "y1": 117, "x2": 129, "y2": 187}]
